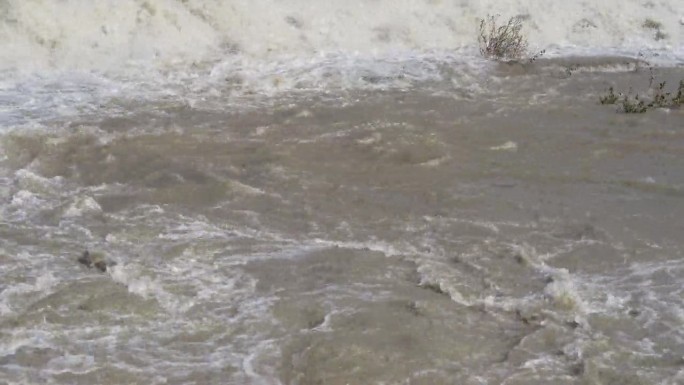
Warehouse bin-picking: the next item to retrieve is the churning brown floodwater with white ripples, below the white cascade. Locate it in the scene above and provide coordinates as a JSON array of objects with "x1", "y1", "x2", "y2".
[{"x1": 0, "y1": 58, "x2": 684, "y2": 385}]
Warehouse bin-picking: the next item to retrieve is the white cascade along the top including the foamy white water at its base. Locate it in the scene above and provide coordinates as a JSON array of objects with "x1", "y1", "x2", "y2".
[{"x1": 0, "y1": 0, "x2": 684, "y2": 123}]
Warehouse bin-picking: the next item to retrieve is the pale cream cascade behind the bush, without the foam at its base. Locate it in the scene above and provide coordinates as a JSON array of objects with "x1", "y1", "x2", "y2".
[{"x1": 0, "y1": 0, "x2": 684, "y2": 71}]
